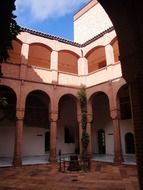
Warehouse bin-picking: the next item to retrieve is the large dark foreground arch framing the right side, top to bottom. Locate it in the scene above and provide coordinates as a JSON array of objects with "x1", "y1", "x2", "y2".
[{"x1": 99, "y1": 0, "x2": 143, "y2": 186}]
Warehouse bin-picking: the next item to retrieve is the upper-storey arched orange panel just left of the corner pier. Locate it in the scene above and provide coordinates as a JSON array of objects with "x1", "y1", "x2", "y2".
[{"x1": 58, "y1": 50, "x2": 79, "y2": 74}]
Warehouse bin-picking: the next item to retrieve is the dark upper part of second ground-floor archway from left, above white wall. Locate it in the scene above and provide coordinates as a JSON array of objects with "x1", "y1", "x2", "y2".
[{"x1": 24, "y1": 90, "x2": 50, "y2": 128}]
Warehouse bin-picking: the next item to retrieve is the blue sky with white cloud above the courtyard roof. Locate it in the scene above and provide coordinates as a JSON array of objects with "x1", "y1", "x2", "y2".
[{"x1": 15, "y1": 0, "x2": 90, "y2": 41}]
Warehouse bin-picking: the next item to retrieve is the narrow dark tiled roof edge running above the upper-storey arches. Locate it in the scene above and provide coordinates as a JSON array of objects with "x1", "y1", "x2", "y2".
[{"x1": 21, "y1": 26, "x2": 114, "y2": 47}]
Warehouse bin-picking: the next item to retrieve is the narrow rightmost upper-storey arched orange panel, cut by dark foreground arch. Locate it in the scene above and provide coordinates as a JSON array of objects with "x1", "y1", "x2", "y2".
[{"x1": 111, "y1": 37, "x2": 119, "y2": 63}]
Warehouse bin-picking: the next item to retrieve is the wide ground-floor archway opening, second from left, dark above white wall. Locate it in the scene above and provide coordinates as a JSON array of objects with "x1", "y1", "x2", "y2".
[{"x1": 23, "y1": 90, "x2": 50, "y2": 159}]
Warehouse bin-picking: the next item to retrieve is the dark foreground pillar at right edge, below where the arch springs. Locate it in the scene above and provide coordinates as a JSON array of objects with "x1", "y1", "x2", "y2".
[{"x1": 129, "y1": 80, "x2": 143, "y2": 186}]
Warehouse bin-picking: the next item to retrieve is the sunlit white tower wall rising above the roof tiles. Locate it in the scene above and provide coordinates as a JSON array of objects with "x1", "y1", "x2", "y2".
[{"x1": 74, "y1": 3, "x2": 112, "y2": 43}]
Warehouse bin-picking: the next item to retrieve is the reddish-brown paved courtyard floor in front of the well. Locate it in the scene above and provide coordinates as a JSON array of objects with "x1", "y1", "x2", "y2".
[{"x1": 0, "y1": 161, "x2": 139, "y2": 190}]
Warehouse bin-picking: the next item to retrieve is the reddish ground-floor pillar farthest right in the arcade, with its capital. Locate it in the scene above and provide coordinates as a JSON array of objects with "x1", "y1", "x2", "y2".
[{"x1": 111, "y1": 109, "x2": 123, "y2": 164}]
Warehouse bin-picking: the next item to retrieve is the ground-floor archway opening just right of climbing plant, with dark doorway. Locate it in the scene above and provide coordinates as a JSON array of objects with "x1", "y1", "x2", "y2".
[{"x1": 91, "y1": 92, "x2": 114, "y2": 156}]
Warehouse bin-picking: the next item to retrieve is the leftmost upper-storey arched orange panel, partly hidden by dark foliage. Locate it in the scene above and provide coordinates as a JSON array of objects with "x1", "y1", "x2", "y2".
[{"x1": 7, "y1": 39, "x2": 22, "y2": 64}]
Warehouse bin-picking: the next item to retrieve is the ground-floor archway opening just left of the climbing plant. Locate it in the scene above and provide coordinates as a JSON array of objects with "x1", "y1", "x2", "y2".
[{"x1": 57, "y1": 94, "x2": 79, "y2": 154}]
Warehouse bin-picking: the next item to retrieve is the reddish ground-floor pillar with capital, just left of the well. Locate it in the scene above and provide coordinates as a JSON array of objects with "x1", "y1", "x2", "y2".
[{"x1": 50, "y1": 114, "x2": 58, "y2": 162}]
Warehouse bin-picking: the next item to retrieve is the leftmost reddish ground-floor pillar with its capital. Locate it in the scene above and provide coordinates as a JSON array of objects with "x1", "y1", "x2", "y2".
[{"x1": 13, "y1": 109, "x2": 24, "y2": 166}]
